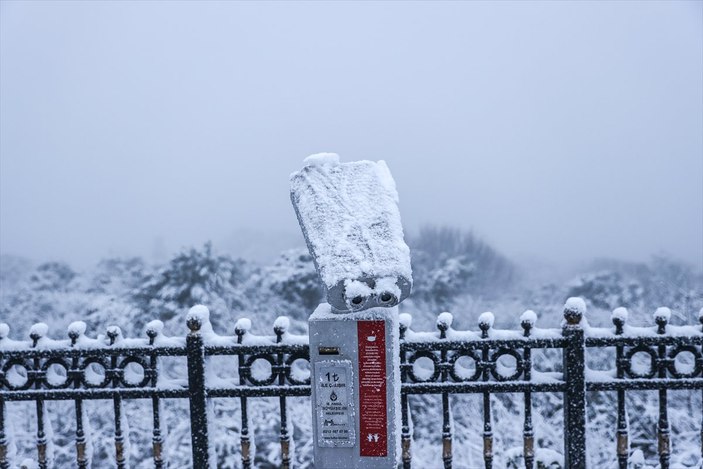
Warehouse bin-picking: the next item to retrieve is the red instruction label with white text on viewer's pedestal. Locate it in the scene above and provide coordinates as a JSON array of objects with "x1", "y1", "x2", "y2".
[{"x1": 357, "y1": 321, "x2": 388, "y2": 457}]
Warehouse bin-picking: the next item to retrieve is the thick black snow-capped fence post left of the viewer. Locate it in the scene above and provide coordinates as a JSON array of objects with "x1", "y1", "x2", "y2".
[{"x1": 186, "y1": 307, "x2": 214, "y2": 469}]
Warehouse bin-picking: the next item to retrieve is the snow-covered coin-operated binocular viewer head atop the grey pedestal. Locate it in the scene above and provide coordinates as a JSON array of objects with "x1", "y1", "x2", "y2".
[{"x1": 290, "y1": 153, "x2": 412, "y2": 312}]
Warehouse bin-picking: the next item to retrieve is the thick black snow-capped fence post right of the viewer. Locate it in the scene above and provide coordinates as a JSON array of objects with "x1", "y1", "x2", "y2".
[{"x1": 562, "y1": 298, "x2": 586, "y2": 469}]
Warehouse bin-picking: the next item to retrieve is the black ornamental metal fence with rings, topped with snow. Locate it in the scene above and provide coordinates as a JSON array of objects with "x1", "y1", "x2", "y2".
[{"x1": 0, "y1": 298, "x2": 703, "y2": 469}]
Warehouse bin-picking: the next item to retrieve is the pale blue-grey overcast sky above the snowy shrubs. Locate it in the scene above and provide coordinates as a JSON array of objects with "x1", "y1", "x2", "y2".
[{"x1": 0, "y1": 1, "x2": 703, "y2": 267}]
